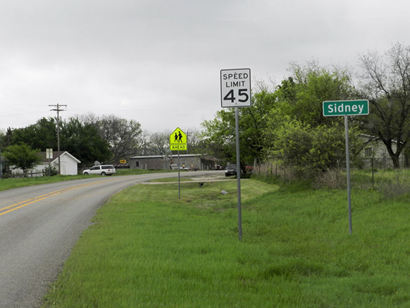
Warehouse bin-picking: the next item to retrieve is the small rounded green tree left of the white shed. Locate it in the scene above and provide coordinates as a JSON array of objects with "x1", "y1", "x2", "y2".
[{"x1": 3, "y1": 143, "x2": 40, "y2": 176}]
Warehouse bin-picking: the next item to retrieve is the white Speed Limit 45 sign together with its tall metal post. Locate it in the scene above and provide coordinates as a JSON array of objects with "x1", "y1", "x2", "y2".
[{"x1": 220, "y1": 68, "x2": 251, "y2": 241}]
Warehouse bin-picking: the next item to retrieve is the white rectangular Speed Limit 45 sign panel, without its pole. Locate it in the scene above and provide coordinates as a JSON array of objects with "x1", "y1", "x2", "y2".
[{"x1": 221, "y1": 68, "x2": 251, "y2": 108}]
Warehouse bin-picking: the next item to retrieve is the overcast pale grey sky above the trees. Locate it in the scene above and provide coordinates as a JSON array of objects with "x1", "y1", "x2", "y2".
[{"x1": 0, "y1": 0, "x2": 410, "y2": 132}]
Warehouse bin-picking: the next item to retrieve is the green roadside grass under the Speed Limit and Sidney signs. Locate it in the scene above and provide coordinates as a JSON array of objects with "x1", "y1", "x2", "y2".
[{"x1": 44, "y1": 180, "x2": 410, "y2": 307}]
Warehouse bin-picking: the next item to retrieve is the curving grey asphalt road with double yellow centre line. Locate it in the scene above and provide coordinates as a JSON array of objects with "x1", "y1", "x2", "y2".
[{"x1": 0, "y1": 171, "x2": 221, "y2": 307}]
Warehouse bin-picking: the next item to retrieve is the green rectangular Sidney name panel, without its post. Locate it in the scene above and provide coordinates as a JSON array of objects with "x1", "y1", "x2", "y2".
[{"x1": 323, "y1": 99, "x2": 369, "y2": 117}]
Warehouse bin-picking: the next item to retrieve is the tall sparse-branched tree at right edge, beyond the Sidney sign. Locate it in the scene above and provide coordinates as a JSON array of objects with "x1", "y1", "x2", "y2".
[{"x1": 361, "y1": 43, "x2": 410, "y2": 168}]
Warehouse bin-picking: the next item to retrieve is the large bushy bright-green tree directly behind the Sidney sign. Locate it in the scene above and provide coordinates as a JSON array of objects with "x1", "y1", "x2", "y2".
[{"x1": 264, "y1": 65, "x2": 364, "y2": 174}]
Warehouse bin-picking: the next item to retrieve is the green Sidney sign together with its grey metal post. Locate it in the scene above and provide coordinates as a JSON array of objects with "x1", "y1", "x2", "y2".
[{"x1": 323, "y1": 99, "x2": 369, "y2": 234}]
